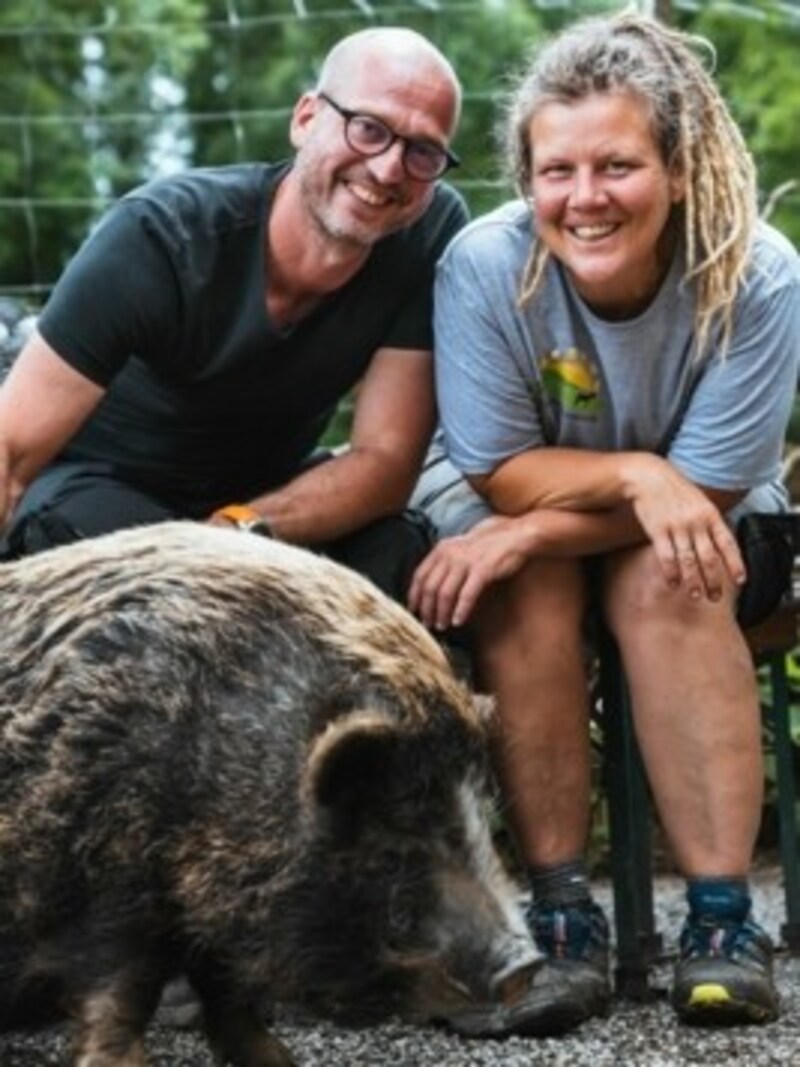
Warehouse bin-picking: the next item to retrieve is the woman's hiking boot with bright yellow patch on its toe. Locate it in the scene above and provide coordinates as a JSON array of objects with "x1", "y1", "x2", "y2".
[{"x1": 672, "y1": 915, "x2": 779, "y2": 1026}]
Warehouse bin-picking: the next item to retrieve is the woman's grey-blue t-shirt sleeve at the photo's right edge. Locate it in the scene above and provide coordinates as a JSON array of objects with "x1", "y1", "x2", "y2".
[{"x1": 669, "y1": 241, "x2": 800, "y2": 490}]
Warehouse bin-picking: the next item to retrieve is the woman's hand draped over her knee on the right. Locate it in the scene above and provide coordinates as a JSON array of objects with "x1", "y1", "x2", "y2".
[{"x1": 624, "y1": 452, "x2": 747, "y2": 601}]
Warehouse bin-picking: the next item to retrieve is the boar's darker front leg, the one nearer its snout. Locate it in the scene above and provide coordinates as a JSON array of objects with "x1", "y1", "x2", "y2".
[{"x1": 189, "y1": 969, "x2": 295, "y2": 1067}]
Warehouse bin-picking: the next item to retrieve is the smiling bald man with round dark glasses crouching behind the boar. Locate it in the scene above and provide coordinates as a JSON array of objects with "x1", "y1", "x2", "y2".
[{"x1": 0, "y1": 29, "x2": 465, "y2": 596}]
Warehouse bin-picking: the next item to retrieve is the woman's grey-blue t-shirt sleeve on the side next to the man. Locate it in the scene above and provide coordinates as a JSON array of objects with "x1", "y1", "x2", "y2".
[{"x1": 434, "y1": 229, "x2": 546, "y2": 475}]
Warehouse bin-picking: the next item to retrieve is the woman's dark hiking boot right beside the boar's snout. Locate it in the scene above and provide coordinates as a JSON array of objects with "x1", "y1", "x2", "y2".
[{"x1": 506, "y1": 902, "x2": 611, "y2": 1037}]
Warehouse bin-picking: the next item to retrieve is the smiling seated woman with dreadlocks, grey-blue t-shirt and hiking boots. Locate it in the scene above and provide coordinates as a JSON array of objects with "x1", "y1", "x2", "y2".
[{"x1": 410, "y1": 14, "x2": 800, "y2": 1034}]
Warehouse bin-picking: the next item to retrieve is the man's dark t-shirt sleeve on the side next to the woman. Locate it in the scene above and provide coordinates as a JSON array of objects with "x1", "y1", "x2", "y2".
[{"x1": 384, "y1": 186, "x2": 468, "y2": 350}]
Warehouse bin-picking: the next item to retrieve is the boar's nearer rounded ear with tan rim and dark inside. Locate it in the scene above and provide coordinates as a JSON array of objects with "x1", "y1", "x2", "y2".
[{"x1": 304, "y1": 712, "x2": 409, "y2": 831}]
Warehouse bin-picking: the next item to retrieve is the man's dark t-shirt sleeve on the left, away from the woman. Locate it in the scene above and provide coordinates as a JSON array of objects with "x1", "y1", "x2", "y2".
[{"x1": 38, "y1": 201, "x2": 180, "y2": 386}]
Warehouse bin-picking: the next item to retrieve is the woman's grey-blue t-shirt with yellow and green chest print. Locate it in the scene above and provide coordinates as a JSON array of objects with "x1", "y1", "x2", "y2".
[{"x1": 435, "y1": 201, "x2": 800, "y2": 520}]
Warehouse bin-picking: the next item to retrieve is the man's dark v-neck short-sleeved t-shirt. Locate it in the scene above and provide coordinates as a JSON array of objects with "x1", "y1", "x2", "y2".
[{"x1": 38, "y1": 162, "x2": 466, "y2": 504}]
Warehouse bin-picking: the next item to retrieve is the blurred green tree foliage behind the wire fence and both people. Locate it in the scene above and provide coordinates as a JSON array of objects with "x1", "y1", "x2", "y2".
[{"x1": 0, "y1": 0, "x2": 800, "y2": 292}]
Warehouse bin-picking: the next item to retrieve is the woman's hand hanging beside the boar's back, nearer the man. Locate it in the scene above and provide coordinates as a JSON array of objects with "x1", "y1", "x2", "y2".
[{"x1": 409, "y1": 515, "x2": 533, "y2": 630}]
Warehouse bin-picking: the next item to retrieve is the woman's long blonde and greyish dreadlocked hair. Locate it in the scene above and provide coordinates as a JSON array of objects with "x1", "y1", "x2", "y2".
[{"x1": 506, "y1": 13, "x2": 757, "y2": 355}]
